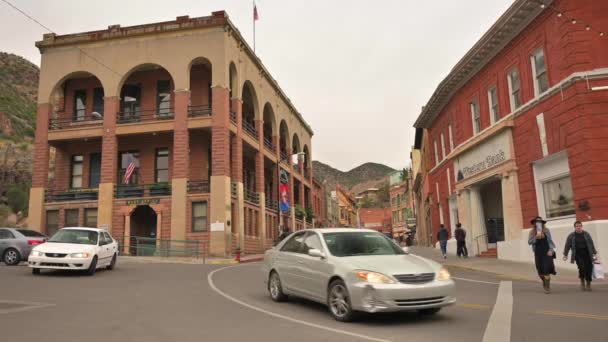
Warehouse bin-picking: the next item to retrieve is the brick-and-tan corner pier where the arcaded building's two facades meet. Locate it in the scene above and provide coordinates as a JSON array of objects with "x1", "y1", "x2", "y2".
[{"x1": 209, "y1": 86, "x2": 233, "y2": 256}]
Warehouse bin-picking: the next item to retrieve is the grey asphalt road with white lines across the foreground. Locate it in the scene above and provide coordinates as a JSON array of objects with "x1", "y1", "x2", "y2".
[{"x1": 0, "y1": 261, "x2": 608, "y2": 342}]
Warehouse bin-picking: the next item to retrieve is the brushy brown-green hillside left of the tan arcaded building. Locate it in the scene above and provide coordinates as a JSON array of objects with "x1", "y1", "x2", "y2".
[{"x1": 0, "y1": 52, "x2": 40, "y2": 141}]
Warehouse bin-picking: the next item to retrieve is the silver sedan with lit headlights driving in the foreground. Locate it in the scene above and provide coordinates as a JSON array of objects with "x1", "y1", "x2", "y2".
[{"x1": 263, "y1": 228, "x2": 456, "y2": 321}]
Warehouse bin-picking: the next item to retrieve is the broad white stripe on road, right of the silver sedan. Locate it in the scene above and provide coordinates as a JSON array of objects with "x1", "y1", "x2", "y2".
[{"x1": 483, "y1": 281, "x2": 513, "y2": 342}]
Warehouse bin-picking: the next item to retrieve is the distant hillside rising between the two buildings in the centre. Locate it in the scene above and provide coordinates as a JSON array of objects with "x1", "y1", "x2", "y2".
[{"x1": 312, "y1": 161, "x2": 395, "y2": 193}]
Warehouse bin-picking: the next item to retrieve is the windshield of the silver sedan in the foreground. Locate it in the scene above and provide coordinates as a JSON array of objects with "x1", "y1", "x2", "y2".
[{"x1": 323, "y1": 232, "x2": 405, "y2": 257}]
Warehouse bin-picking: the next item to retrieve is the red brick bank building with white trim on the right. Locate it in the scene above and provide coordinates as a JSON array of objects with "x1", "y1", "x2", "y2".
[{"x1": 415, "y1": 0, "x2": 608, "y2": 260}]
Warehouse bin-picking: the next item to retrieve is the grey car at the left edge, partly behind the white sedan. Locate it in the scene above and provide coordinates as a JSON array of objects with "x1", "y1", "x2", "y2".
[{"x1": 0, "y1": 228, "x2": 47, "y2": 266}]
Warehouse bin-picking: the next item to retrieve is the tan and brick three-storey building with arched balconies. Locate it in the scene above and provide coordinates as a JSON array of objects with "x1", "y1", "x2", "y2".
[{"x1": 29, "y1": 11, "x2": 313, "y2": 255}]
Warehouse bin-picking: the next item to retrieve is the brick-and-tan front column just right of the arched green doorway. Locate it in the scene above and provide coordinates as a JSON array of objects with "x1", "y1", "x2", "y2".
[{"x1": 171, "y1": 90, "x2": 190, "y2": 240}]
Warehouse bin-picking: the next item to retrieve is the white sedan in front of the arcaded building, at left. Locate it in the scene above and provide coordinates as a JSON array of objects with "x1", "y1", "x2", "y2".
[{"x1": 28, "y1": 227, "x2": 118, "y2": 275}]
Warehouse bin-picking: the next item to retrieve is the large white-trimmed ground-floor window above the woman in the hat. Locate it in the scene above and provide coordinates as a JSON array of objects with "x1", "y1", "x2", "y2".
[{"x1": 534, "y1": 152, "x2": 576, "y2": 220}]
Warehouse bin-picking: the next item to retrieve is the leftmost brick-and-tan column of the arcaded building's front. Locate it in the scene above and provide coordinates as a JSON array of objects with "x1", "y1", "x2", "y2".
[{"x1": 28, "y1": 103, "x2": 52, "y2": 232}]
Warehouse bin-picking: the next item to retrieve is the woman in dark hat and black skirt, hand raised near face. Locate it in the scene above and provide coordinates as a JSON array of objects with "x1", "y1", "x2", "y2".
[{"x1": 528, "y1": 216, "x2": 557, "y2": 294}]
